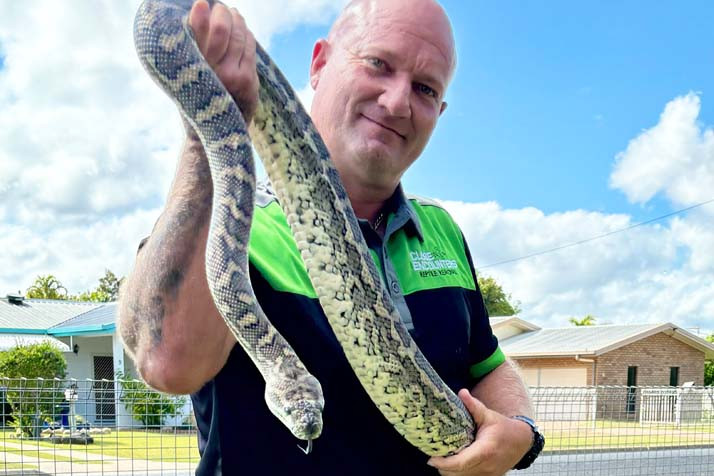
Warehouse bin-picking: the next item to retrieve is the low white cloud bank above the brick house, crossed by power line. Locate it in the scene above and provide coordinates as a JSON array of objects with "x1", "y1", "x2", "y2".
[{"x1": 444, "y1": 202, "x2": 714, "y2": 328}]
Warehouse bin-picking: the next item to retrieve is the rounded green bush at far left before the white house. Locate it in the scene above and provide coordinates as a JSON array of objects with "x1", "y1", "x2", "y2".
[{"x1": 0, "y1": 342, "x2": 67, "y2": 436}]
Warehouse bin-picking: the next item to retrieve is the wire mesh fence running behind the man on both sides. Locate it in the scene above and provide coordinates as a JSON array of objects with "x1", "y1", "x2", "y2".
[{"x1": 0, "y1": 379, "x2": 714, "y2": 476}]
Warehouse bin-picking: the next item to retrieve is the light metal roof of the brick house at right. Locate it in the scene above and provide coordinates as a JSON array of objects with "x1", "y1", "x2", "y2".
[{"x1": 500, "y1": 322, "x2": 714, "y2": 359}]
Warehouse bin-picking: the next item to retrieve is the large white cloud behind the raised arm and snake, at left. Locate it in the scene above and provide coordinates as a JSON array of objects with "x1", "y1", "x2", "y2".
[{"x1": 0, "y1": 0, "x2": 344, "y2": 295}]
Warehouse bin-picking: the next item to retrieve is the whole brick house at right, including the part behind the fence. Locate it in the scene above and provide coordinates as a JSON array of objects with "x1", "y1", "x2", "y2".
[{"x1": 491, "y1": 316, "x2": 714, "y2": 421}]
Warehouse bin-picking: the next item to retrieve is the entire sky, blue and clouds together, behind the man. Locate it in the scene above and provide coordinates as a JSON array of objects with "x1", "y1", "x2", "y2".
[{"x1": 0, "y1": 0, "x2": 714, "y2": 330}]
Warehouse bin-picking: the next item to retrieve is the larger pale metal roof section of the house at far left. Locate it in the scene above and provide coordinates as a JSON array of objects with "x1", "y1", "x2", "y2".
[{"x1": 0, "y1": 298, "x2": 104, "y2": 334}]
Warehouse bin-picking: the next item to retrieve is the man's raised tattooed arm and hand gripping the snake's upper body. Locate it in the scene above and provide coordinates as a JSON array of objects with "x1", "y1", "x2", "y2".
[{"x1": 118, "y1": 0, "x2": 259, "y2": 393}]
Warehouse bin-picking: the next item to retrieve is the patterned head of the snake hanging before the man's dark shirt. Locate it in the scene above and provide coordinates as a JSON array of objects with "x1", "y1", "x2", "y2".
[{"x1": 265, "y1": 362, "x2": 325, "y2": 441}]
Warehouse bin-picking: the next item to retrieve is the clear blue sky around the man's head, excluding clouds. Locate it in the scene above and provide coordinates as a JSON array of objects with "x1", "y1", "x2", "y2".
[{"x1": 271, "y1": 0, "x2": 714, "y2": 221}]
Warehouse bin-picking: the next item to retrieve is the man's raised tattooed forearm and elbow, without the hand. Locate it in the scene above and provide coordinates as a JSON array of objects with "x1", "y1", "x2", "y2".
[{"x1": 119, "y1": 123, "x2": 234, "y2": 393}]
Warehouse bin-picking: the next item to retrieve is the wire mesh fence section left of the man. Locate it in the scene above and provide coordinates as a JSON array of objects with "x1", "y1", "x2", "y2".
[{"x1": 0, "y1": 379, "x2": 199, "y2": 475}]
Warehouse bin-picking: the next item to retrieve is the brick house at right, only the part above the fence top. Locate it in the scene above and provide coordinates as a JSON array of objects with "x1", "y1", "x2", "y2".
[{"x1": 491, "y1": 316, "x2": 714, "y2": 387}]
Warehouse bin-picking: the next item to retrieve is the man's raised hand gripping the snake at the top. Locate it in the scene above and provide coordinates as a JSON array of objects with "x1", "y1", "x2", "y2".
[{"x1": 188, "y1": 0, "x2": 260, "y2": 122}]
